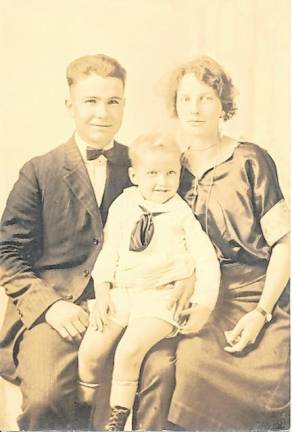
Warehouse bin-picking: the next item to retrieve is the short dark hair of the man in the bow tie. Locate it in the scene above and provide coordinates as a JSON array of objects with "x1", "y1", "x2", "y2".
[{"x1": 66, "y1": 54, "x2": 126, "y2": 87}]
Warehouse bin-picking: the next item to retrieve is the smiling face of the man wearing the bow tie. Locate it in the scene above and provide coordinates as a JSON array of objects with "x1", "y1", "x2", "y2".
[{"x1": 66, "y1": 74, "x2": 124, "y2": 148}]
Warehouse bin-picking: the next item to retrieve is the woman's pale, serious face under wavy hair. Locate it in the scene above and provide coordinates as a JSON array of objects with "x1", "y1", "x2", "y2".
[{"x1": 176, "y1": 73, "x2": 223, "y2": 138}]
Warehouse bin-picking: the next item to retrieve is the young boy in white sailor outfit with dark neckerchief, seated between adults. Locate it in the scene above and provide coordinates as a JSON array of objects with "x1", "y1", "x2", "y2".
[{"x1": 79, "y1": 134, "x2": 220, "y2": 431}]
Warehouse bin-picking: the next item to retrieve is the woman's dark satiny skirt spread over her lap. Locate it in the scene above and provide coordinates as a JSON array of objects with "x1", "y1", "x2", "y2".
[{"x1": 169, "y1": 281, "x2": 289, "y2": 430}]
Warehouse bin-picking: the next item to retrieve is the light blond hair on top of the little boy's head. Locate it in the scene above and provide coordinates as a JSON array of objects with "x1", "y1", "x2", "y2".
[{"x1": 129, "y1": 132, "x2": 181, "y2": 166}]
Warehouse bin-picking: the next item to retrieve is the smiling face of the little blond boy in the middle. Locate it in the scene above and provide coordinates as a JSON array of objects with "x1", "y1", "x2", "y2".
[{"x1": 129, "y1": 150, "x2": 181, "y2": 203}]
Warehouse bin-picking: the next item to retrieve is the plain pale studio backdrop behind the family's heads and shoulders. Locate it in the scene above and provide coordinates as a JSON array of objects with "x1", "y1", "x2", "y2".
[{"x1": 0, "y1": 0, "x2": 289, "y2": 429}]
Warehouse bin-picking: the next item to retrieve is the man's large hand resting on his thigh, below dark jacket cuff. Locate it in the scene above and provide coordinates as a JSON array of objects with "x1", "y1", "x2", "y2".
[{"x1": 45, "y1": 300, "x2": 89, "y2": 342}]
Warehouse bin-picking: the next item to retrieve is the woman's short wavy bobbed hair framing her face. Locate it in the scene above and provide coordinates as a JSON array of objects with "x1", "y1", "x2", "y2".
[{"x1": 163, "y1": 56, "x2": 237, "y2": 121}]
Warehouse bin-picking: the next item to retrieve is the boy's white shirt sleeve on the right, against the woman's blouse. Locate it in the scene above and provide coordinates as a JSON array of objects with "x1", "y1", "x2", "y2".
[{"x1": 184, "y1": 211, "x2": 220, "y2": 310}]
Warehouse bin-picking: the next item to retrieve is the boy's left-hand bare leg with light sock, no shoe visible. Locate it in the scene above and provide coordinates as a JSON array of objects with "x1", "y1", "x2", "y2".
[{"x1": 78, "y1": 321, "x2": 124, "y2": 404}]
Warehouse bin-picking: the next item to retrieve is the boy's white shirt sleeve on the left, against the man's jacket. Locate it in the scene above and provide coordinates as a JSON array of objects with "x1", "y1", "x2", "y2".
[{"x1": 92, "y1": 195, "x2": 125, "y2": 285}]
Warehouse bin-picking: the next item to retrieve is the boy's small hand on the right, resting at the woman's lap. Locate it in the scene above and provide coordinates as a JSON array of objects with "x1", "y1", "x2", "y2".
[{"x1": 180, "y1": 303, "x2": 212, "y2": 336}]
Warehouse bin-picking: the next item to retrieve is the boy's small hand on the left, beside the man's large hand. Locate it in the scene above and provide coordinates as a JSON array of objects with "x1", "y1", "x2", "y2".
[{"x1": 89, "y1": 282, "x2": 115, "y2": 332}]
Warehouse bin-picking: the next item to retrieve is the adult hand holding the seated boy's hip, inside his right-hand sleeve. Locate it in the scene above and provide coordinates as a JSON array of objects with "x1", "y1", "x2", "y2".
[{"x1": 167, "y1": 273, "x2": 195, "y2": 321}]
